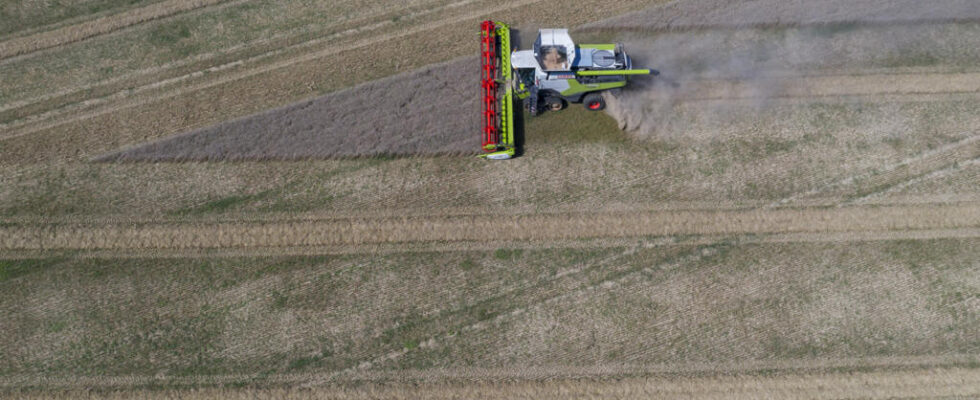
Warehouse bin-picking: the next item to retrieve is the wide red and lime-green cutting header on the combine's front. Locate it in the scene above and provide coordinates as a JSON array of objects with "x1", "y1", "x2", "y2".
[{"x1": 480, "y1": 21, "x2": 517, "y2": 160}]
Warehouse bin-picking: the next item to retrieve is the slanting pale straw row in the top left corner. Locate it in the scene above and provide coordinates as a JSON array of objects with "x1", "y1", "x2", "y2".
[{"x1": 0, "y1": 0, "x2": 235, "y2": 60}]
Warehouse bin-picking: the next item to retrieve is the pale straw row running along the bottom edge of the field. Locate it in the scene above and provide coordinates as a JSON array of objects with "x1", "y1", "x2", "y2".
[{"x1": 5, "y1": 368, "x2": 980, "y2": 400}]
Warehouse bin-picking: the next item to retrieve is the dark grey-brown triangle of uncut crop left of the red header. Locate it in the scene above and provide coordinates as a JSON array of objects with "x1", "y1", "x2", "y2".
[{"x1": 98, "y1": 55, "x2": 480, "y2": 161}]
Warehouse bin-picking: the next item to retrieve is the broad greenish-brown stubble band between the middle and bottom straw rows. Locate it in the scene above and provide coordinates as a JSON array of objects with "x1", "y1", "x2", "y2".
[{"x1": 0, "y1": 239, "x2": 980, "y2": 391}]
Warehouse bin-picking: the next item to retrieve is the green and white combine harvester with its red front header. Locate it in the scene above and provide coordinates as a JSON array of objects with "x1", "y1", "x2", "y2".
[{"x1": 480, "y1": 21, "x2": 656, "y2": 160}]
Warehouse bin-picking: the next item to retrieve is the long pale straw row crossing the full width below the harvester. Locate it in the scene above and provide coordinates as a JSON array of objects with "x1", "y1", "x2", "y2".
[{"x1": 0, "y1": 203, "x2": 980, "y2": 250}]
